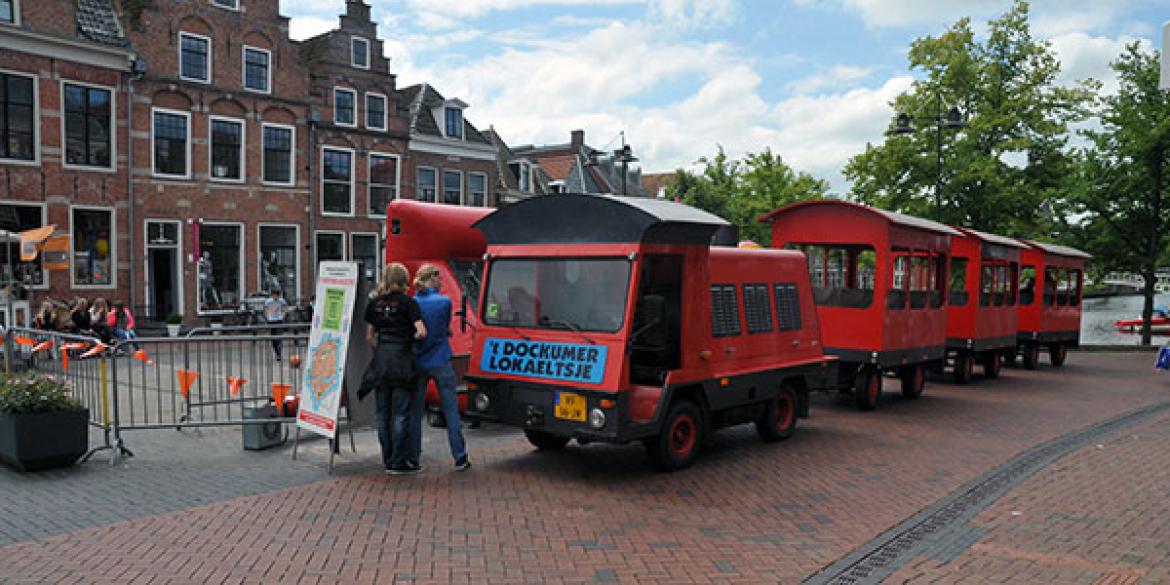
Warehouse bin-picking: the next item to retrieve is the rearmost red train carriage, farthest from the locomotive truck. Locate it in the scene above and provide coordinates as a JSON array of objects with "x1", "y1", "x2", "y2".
[{"x1": 1018, "y1": 240, "x2": 1093, "y2": 369}]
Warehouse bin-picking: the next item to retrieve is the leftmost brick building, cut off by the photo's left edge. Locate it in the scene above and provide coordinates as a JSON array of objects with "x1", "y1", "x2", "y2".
[{"x1": 0, "y1": 0, "x2": 133, "y2": 325}]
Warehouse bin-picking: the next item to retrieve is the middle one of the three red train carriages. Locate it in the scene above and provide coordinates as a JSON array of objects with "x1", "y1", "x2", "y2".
[{"x1": 947, "y1": 227, "x2": 1026, "y2": 384}]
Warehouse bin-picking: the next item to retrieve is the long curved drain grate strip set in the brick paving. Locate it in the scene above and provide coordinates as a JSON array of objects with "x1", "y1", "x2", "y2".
[{"x1": 805, "y1": 402, "x2": 1170, "y2": 585}]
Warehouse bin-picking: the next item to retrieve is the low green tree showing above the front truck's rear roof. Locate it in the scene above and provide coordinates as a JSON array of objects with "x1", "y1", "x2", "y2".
[{"x1": 667, "y1": 147, "x2": 828, "y2": 246}]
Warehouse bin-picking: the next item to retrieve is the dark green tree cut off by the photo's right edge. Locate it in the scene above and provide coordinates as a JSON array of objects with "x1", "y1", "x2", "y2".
[{"x1": 1068, "y1": 42, "x2": 1170, "y2": 345}]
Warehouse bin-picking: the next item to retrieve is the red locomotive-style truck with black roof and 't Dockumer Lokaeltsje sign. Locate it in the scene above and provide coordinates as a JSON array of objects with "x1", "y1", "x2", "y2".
[{"x1": 456, "y1": 194, "x2": 835, "y2": 470}]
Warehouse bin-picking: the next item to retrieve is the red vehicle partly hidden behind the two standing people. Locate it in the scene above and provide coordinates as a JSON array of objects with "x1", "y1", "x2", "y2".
[{"x1": 385, "y1": 199, "x2": 494, "y2": 426}]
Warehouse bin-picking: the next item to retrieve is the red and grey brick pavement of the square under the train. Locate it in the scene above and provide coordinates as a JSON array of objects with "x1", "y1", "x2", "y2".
[{"x1": 0, "y1": 353, "x2": 1170, "y2": 583}]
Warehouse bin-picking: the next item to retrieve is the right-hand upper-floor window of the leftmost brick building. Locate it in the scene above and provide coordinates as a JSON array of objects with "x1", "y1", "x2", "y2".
[{"x1": 64, "y1": 83, "x2": 113, "y2": 167}]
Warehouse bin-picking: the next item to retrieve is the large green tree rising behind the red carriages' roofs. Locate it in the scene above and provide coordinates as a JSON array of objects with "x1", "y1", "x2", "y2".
[{"x1": 845, "y1": 0, "x2": 1093, "y2": 238}]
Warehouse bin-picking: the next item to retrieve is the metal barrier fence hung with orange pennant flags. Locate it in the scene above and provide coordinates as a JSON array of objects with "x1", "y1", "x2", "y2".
[{"x1": 5, "y1": 324, "x2": 309, "y2": 463}]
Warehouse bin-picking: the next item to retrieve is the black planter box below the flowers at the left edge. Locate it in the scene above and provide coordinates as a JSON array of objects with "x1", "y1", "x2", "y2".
[{"x1": 0, "y1": 408, "x2": 89, "y2": 472}]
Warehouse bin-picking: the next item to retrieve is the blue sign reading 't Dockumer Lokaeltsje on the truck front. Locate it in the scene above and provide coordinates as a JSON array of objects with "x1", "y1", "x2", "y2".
[{"x1": 480, "y1": 337, "x2": 607, "y2": 384}]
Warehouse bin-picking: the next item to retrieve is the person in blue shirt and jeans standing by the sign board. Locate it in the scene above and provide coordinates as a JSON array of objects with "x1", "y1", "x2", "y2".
[{"x1": 410, "y1": 264, "x2": 472, "y2": 472}]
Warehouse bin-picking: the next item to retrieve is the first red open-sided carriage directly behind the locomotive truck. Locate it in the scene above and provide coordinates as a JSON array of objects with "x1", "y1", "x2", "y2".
[{"x1": 759, "y1": 200, "x2": 959, "y2": 411}]
